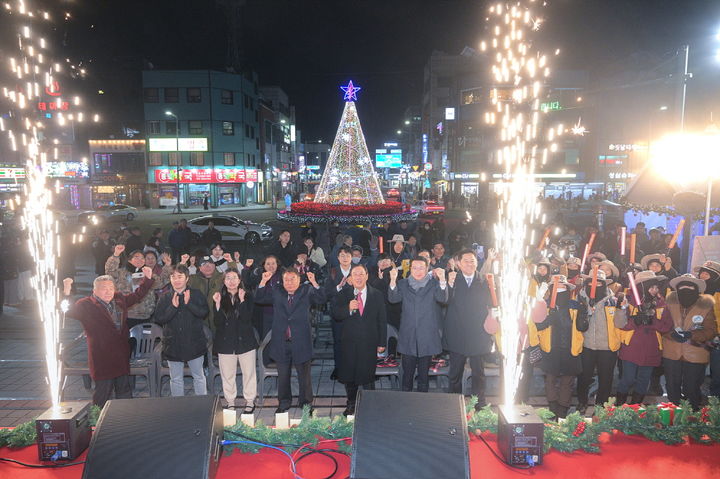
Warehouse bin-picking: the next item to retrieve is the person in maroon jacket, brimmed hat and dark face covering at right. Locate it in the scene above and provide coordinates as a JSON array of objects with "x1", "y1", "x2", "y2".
[{"x1": 615, "y1": 271, "x2": 672, "y2": 404}]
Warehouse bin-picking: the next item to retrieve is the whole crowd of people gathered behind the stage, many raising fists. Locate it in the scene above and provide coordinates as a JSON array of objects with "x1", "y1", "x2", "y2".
[{"x1": 56, "y1": 214, "x2": 720, "y2": 417}]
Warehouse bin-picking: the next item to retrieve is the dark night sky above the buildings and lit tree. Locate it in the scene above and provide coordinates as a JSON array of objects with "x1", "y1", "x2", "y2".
[{"x1": 15, "y1": 0, "x2": 720, "y2": 149}]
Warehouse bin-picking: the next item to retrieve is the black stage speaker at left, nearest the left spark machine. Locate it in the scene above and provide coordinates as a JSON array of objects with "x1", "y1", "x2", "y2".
[{"x1": 82, "y1": 396, "x2": 223, "y2": 479}]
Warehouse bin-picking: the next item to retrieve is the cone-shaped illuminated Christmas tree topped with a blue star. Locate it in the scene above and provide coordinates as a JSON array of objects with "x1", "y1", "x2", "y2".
[{"x1": 315, "y1": 81, "x2": 385, "y2": 205}]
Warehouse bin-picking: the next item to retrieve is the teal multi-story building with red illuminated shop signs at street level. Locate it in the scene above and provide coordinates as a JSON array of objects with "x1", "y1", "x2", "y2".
[{"x1": 143, "y1": 70, "x2": 266, "y2": 207}]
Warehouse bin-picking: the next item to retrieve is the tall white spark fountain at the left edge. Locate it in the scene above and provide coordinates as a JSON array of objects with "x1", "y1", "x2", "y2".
[{"x1": 0, "y1": 0, "x2": 98, "y2": 408}]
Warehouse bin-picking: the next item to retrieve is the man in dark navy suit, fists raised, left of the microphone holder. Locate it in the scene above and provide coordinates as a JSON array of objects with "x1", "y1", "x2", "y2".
[{"x1": 255, "y1": 268, "x2": 325, "y2": 413}]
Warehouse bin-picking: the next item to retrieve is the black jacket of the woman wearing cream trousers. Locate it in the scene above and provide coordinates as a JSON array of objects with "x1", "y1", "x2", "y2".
[{"x1": 213, "y1": 293, "x2": 258, "y2": 354}]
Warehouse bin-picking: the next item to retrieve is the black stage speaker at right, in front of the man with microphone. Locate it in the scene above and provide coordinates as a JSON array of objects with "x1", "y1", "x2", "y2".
[{"x1": 350, "y1": 390, "x2": 470, "y2": 479}]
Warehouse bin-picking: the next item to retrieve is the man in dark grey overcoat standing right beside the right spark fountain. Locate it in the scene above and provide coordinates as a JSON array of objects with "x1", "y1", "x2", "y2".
[{"x1": 443, "y1": 249, "x2": 492, "y2": 409}]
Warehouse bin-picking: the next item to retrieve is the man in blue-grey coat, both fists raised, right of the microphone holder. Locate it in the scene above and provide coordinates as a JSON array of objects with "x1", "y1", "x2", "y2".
[{"x1": 388, "y1": 257, "x2": 448, "y2": 392}]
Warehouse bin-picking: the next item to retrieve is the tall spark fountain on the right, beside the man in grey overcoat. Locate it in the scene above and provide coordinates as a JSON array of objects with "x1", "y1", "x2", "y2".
[{"x1": 480, "y1": 0, "x2": 564, "y2": 405}]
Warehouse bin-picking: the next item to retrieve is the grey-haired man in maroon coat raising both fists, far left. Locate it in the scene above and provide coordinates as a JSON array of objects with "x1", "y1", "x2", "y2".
[{"x1": 63, "y1": 266, "x2": 153, "y2": 407}]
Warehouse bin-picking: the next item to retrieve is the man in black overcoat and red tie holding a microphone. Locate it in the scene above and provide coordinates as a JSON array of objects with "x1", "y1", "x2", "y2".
[{"x1": 333, "y1": 264, "x2": 387, "y2": 416}]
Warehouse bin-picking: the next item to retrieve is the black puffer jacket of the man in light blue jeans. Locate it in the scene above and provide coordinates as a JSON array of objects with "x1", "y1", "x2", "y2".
[{"x1": 155, "y1": 289, "x2": 209, "y2": 361}]
